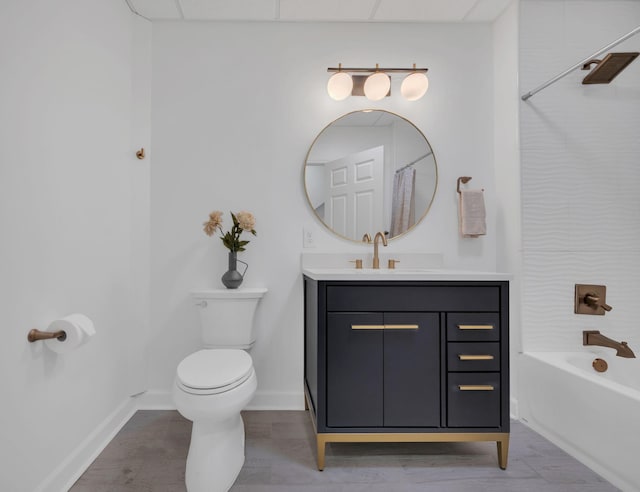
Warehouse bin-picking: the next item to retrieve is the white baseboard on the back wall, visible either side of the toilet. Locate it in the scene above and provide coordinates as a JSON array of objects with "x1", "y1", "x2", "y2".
[{"x1": 137, "y1": 390, "x2": 304, "y2": 410}]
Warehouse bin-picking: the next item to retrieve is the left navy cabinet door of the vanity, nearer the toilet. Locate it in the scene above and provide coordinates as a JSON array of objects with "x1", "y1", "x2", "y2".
[{"x1": 327, "y1": 313, "x2": 384, "y2": 427}]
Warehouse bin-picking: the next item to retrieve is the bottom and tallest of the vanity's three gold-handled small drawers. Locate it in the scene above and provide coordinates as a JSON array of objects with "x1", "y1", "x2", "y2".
[{"x1": 447, "y1": 372, "x2": 501, "y2": 427}]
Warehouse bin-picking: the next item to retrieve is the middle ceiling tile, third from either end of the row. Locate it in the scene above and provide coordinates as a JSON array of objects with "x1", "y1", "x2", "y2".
[{"x1": 280, "y1": 0, "x2": 376, "y2": 21}]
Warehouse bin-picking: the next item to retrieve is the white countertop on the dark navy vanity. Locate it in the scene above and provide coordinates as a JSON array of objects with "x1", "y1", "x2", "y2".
[{"x1": 302, "y1": 267, "x2": 512, "y2": 281}]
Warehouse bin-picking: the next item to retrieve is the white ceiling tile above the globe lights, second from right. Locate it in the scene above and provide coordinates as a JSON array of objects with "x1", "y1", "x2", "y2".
[{"x1": 375, "y1": 0, "x2": 477, "y2": 22}]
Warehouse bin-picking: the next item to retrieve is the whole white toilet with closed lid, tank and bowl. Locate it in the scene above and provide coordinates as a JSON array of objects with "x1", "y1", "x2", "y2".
[{"x1": 173, "y1": 288, "x2": 267, "y2": 492}]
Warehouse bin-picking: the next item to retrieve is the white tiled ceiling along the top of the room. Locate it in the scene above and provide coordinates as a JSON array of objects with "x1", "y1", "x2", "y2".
[{"x1": 125, "y1": 0, "x2": 512, "y2": 22}]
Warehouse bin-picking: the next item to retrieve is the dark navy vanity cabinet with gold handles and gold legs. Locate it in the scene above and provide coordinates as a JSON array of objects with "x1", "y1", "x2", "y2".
[{"x1": 304, "y1": 276, "x2": 509, "y2": 469}]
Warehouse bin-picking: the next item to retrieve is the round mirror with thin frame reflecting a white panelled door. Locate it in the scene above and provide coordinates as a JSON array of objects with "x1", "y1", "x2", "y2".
[{"x1": 304, "y1": 109, "x2": 438, "y2": 241}]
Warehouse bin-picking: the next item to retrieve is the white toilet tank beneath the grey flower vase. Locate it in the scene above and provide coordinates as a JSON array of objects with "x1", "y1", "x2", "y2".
[{"x1": 191, "y1": 288, "x2": 267, "y2": 349}]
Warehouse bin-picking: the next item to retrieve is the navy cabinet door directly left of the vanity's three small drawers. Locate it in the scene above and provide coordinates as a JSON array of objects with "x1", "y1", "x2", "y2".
[{"x1": 384, "y1": 313, "x2": 441, "y2": 427}]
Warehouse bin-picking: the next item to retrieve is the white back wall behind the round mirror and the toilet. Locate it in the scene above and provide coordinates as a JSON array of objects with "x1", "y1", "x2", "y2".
[{"x1": 150, "y1": 22, "x2": 497, "y2": 408}]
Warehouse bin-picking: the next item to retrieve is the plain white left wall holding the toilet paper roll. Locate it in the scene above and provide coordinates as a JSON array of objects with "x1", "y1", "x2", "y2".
[{"x1": 0, "y1": 0, "x2": 149, "y2": 491}]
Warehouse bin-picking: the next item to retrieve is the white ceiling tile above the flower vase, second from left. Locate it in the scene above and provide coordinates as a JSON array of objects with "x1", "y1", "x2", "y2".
[{"x1": 178, "y1": 0, "x2": 277, "y2": 20}]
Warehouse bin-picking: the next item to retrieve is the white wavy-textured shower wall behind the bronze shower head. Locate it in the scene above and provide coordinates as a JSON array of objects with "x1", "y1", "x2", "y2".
[{"x1": 519, "y1": 0, "x2": 640, "y2": 355}]
